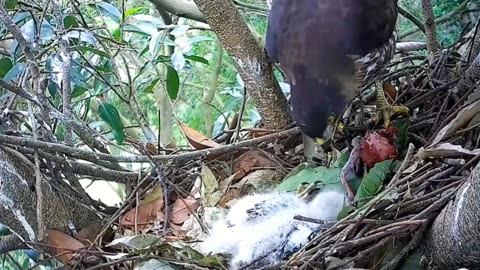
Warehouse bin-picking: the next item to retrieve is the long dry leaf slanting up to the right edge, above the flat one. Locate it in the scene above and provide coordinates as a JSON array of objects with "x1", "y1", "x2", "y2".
[{"x1": 432, "y1": 100, "x2": 480, "y2": 145}]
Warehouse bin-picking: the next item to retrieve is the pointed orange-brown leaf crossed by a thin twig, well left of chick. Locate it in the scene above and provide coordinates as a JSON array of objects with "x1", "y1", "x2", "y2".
[{"x1": 120, "y1": 200, "x2": 163, "y2": 230}]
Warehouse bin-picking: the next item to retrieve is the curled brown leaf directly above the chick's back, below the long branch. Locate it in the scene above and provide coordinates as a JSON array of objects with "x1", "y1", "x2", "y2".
[{"x1": 233, "y1": 150, "x2": 277, "y2": 180}]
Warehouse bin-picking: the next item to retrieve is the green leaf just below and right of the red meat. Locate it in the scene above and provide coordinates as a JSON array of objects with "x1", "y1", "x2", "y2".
[{"x1": 355, "y1": 159, "x2": 393, "y2": 206}]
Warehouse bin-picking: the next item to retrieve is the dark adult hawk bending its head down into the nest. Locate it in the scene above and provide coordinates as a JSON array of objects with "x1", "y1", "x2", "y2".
[{"x1": 266, "y1": 0, "x2": 405, "y2": 148}]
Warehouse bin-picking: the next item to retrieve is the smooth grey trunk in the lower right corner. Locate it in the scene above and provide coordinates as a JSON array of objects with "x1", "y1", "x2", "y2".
[{"x1": 424, "y1": 163, "x2": 480, "y2": 269}]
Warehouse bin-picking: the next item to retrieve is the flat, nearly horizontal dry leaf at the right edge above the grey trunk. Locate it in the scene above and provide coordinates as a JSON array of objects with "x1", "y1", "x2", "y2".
[{"x1": 417, "y1": 143, "x2": 480, "y2": 159}]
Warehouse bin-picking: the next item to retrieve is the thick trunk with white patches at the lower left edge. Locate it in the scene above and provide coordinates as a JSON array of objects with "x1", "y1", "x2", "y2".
[{"x1": 0, "y1": 147, "x2": 99, "y2": 253}]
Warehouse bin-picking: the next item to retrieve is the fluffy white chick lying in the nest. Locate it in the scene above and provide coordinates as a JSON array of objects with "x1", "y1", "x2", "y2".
[{"x1": 200, "y1": 191, "x2": 345, "y2": 269}]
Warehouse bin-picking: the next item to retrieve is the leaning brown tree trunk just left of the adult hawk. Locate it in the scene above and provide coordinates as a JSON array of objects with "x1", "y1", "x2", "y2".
[{"x1": 191, "y1": 0, "x2": 292, "y2": 129}]
